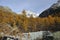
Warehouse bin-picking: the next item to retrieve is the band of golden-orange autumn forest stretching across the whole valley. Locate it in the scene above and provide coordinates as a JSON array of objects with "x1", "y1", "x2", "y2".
[{"x1": 0, "y1": 6, "x2": 60, "y2": 35}]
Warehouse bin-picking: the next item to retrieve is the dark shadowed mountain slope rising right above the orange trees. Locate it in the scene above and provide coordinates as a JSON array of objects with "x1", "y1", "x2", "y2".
[{"x1": 39, "y1": 1, "x2": 60, "y2": 17}]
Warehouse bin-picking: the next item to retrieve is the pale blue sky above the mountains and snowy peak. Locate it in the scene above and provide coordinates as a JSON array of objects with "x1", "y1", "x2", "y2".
[{"x1": 0, "y1": 0, "x2": 57, "y2": 13}]
